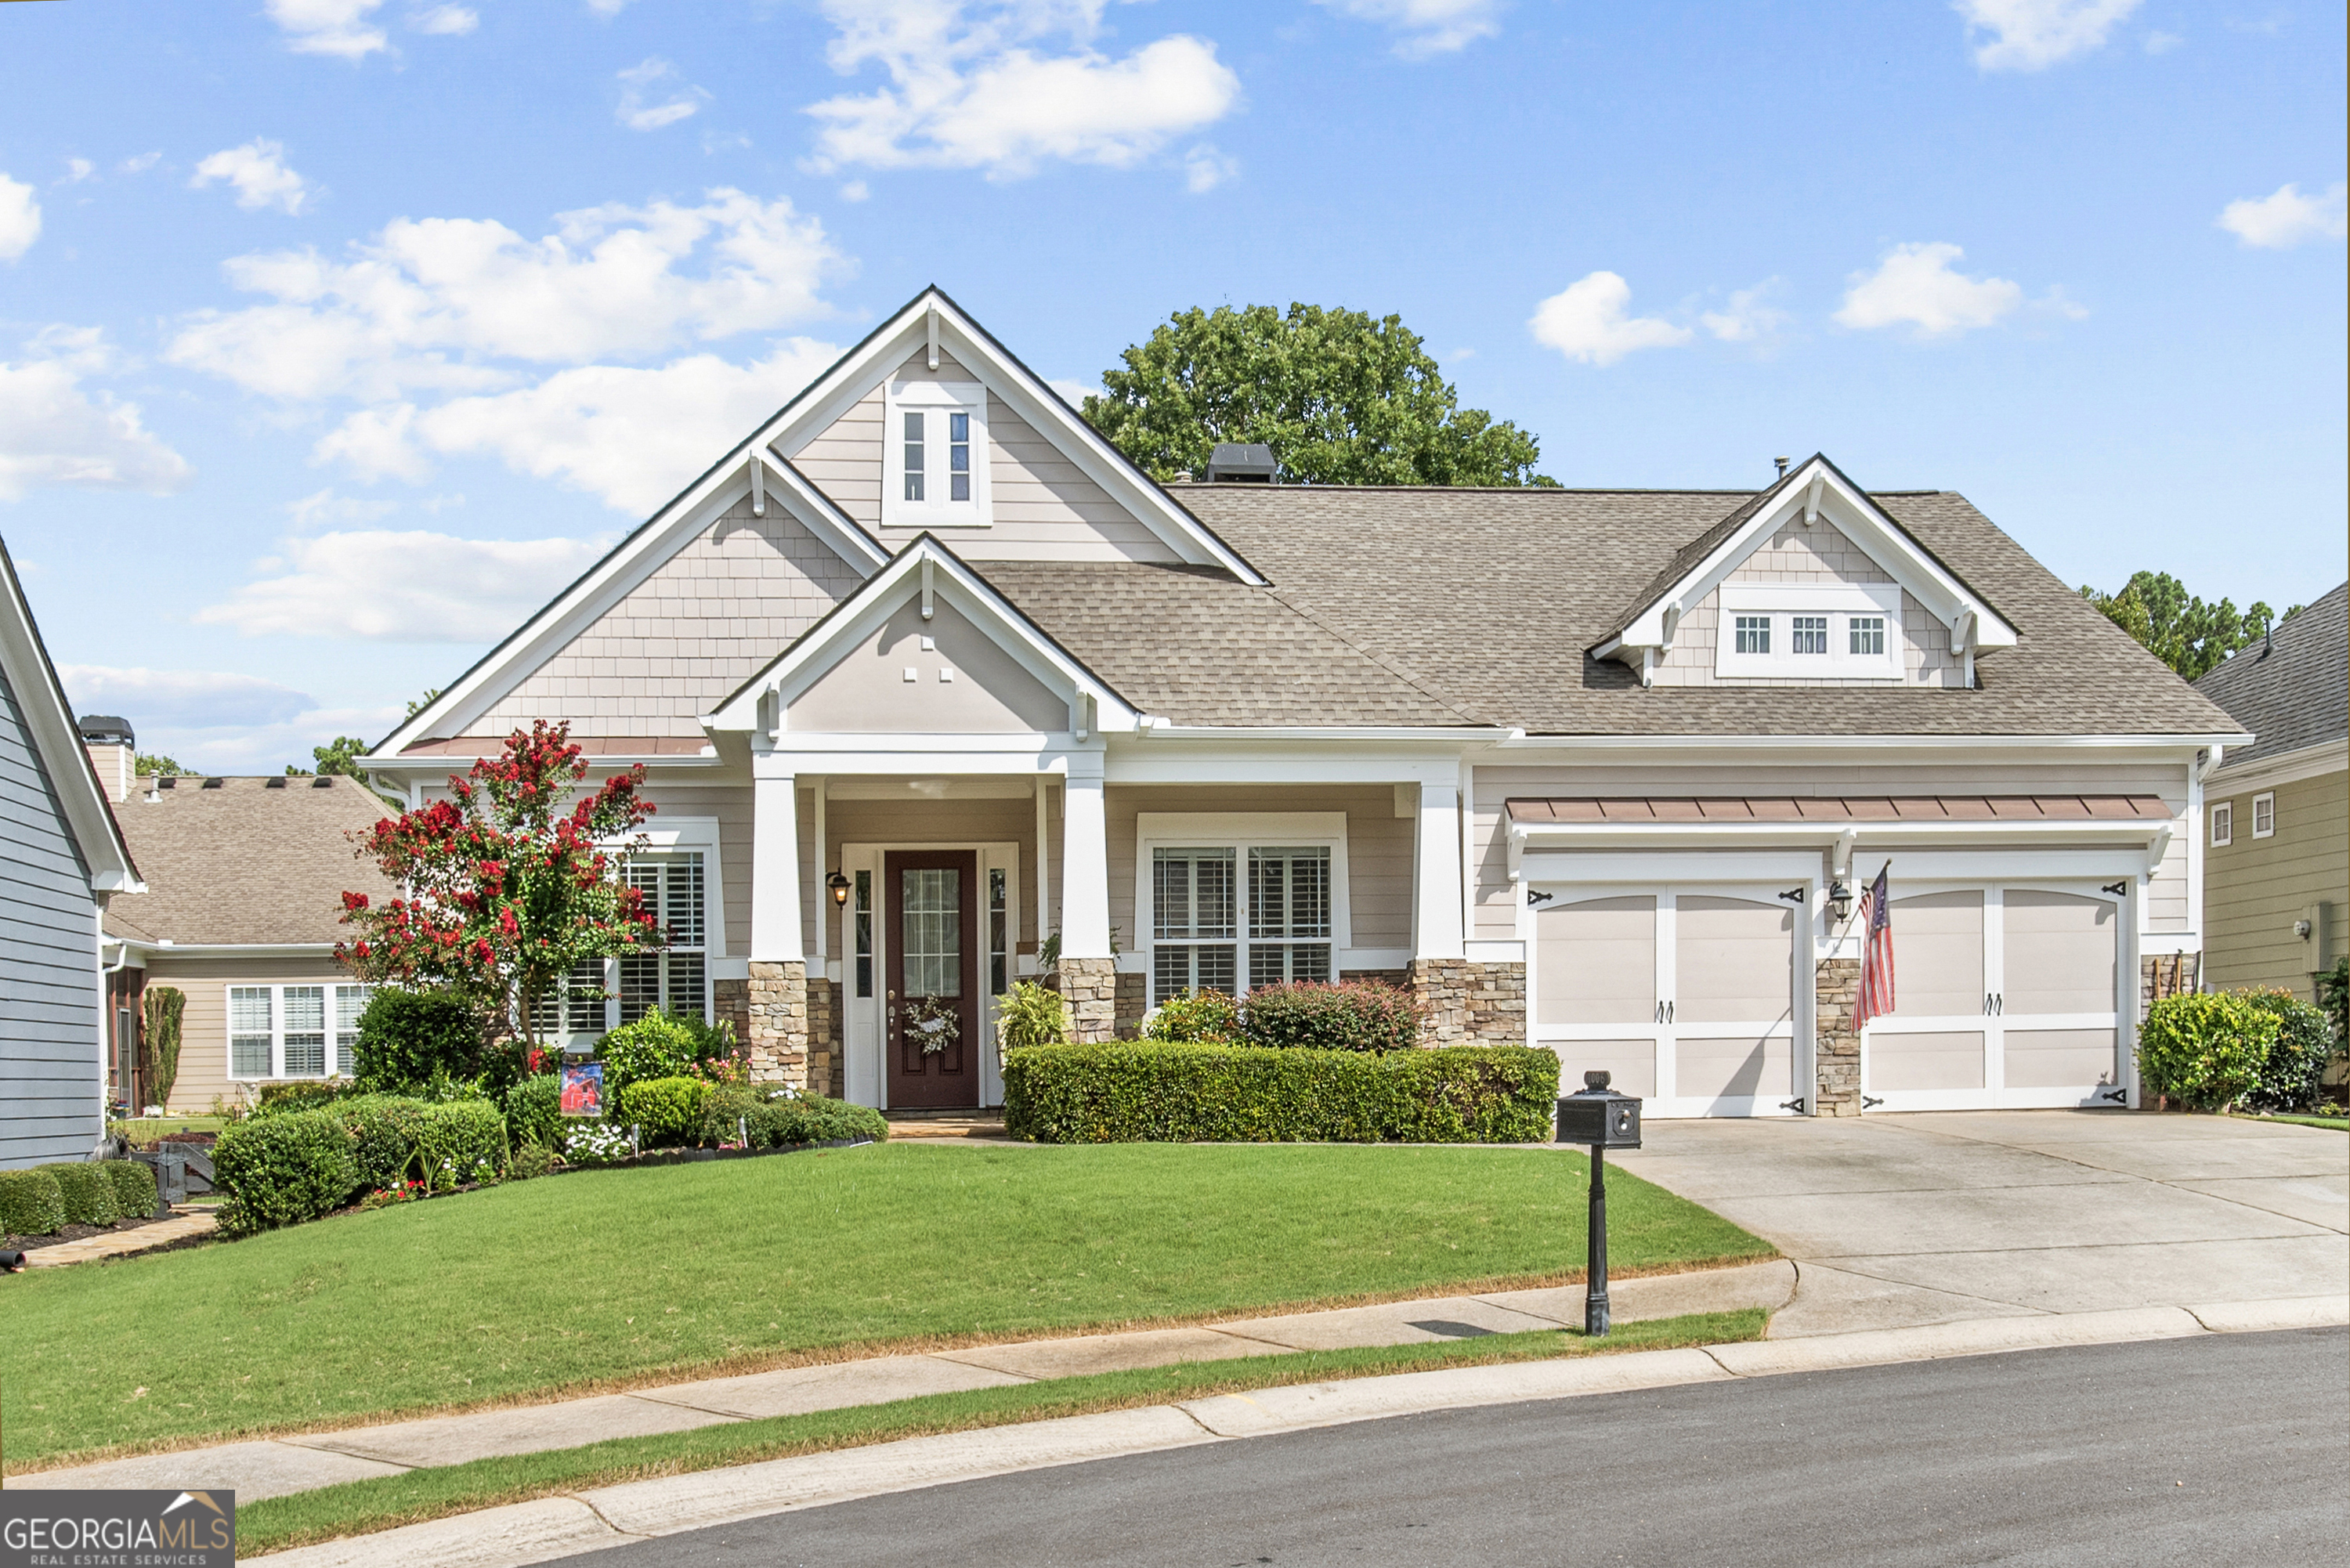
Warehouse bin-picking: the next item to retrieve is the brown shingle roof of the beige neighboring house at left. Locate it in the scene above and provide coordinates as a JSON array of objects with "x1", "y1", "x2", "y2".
[{"x1": 106, "y1": 773, "x2": 395, "y2": 948}]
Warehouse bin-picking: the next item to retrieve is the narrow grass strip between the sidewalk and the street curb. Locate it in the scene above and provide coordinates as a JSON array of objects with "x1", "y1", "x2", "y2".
[{"x1": 237, "y1": 1310, "x2": 1767, "y2": 1554}]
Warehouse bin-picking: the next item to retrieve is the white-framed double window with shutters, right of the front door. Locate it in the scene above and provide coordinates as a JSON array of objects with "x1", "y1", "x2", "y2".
[{"x1": 1149, "y1": 842, "x2": 1340, "y2": 1006}]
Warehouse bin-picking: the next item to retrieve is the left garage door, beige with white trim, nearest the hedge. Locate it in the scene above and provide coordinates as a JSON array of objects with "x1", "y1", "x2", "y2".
[{"x1": 1532, "y1": 887, "x2": 1802, "y2": 1117}]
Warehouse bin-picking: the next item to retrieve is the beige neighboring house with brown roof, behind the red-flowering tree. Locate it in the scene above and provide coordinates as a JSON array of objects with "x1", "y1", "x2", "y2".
[{"x1": 82, "y1": 717, "x2": 390, "y2": 1115}]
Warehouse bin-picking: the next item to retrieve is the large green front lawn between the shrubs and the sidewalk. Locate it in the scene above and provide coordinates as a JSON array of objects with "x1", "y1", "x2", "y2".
[{"x1": 0, "y1": 1145, "x2": 1772, "y2": 1467}]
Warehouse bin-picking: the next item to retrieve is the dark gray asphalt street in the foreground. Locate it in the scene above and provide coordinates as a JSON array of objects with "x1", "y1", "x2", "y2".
[{"x1": 569, "y1": 1328, "x2": 2350, "y2": 1568}]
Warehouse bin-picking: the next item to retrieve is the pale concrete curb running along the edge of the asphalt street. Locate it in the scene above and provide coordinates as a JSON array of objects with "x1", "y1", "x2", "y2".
[{"x1": 268, "y1": 1295, "x2": 2350, "y2": 1568}]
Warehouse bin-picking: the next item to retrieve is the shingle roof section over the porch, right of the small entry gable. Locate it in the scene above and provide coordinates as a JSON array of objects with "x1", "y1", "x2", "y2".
[{"x1": 973, "y1": 562, "x2": 1478, "y2": 728}]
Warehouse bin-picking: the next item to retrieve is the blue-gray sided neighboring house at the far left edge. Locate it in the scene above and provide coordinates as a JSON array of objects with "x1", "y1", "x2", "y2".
[{"x1": 0, "y1": 543, "x2": 139, "y2": 1169}]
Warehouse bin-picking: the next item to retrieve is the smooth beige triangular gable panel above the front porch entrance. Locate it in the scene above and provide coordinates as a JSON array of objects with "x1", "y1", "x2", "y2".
[{"x1": 787, "y1": 594, "x2": 1069, "y2": 733}]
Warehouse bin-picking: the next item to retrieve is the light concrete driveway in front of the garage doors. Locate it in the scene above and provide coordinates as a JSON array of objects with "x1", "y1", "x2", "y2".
[{"x1": 1619, "y1": 1110, "x2": 2350, "y2": 1338}]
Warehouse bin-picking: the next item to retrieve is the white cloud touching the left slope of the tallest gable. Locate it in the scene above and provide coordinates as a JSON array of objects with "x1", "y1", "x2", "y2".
[{"x1": 317, "y1": 338, "x2": 841, "y2": 515}]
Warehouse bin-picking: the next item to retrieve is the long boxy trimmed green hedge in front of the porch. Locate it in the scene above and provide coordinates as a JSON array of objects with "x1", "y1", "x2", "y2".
[{"x1": 1003, "y1": 1042, "x2": 1558, "y2": 1143}]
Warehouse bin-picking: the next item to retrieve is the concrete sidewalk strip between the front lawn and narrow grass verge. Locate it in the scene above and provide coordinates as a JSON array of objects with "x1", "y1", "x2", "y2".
[{"x1": 7, "y1": 1260, "x2": 1795, "y2": 1502}]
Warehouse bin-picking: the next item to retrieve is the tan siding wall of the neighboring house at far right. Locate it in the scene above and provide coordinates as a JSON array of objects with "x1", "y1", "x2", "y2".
[{"x1": 2204, "y1": 773, "x2": 2350, "y2": 997}]
